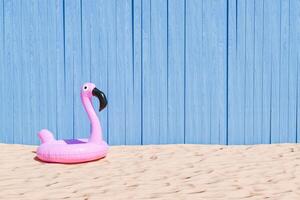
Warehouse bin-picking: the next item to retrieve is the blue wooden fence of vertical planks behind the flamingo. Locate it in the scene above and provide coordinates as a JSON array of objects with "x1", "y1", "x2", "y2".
[{"x1": 0, "y1": 0, "x2": 300, "y2": 144}]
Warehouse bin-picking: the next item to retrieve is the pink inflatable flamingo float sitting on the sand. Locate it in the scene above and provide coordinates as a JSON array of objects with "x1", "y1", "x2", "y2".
[{"x1": 37, "y1": 83, "x2": 108, "y2": 163}]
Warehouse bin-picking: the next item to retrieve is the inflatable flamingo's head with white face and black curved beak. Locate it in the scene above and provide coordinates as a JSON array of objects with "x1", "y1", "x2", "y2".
[{"x1": 81, "y1": 83, "x2": 107, "y2": 111}]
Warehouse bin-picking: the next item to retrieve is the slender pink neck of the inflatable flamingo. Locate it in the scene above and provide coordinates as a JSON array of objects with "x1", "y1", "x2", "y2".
[{"x1": 81, "y1": 95, "x2": 102, "y2": 143}]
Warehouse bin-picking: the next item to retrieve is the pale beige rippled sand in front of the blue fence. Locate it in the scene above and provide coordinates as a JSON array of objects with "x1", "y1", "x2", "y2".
[{"x1": 0, "y1": 144, "x2": 300, "y2": 200}]
